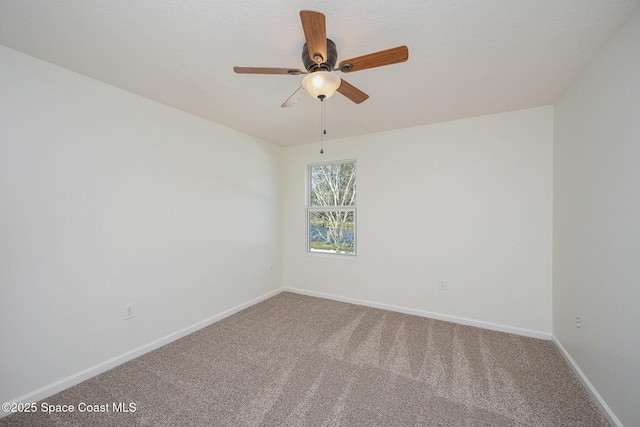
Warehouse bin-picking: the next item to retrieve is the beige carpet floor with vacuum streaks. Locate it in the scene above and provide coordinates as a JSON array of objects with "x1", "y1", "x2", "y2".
[{"x1": 0, "y1": 292, "x2": 608, "y2": 427}]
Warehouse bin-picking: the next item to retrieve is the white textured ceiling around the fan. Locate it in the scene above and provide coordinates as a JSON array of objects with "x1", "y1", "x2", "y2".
[{"x1": 0, "y1": 0, "x2": 640, "y2": 145}]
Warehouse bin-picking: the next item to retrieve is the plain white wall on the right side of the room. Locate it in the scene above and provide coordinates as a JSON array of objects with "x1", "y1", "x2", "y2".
[{"x1": 553, "y1": 7, "x2": 640, "y2": 426}]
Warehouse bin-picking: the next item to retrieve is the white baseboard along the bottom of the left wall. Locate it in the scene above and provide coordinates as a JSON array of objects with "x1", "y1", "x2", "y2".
[{"x1": 0, "y1": 288, "x2": 282, "y2": 418}]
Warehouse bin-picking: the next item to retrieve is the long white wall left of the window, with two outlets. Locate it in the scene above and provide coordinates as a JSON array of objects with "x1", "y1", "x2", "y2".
[{"x1": 0, "y1": 47, "x2": 282, "y2": 402}]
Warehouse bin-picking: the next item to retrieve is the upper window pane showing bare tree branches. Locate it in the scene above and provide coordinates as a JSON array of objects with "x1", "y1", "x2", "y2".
[{"x1": 309, "y1": 162, "x2": 356, "y2": 206}]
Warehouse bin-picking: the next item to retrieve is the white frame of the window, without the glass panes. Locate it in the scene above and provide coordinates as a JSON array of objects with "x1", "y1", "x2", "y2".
[{"x1": 305, "y1": 159, "x2": 358, "y2": 258}]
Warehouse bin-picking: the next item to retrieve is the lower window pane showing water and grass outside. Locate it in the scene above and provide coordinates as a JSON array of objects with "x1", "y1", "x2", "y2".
[{"x1": 309, "y1": 211, "x2": 355, "y2": 255}]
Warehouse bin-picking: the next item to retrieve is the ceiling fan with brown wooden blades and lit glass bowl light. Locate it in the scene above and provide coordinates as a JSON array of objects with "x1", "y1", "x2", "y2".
[{"x1": 233, "y1": 10, "x2": 409, "y2": 107}]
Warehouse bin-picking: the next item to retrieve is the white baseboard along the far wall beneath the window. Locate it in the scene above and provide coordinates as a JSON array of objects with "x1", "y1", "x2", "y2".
[{"x1": 282, "y1": 286, "x2": 551, "y2": 340}]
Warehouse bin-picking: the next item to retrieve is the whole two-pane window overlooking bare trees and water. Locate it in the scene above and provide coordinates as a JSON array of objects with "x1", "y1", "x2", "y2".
[{"x1": 307, "y1": 160, "x2": 356, "y2": 255}]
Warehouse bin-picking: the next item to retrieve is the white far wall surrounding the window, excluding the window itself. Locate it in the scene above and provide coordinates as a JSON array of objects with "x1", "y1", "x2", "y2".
[{"x1": 283, "y1": 104, "x2": 553, "y2": 335}]
